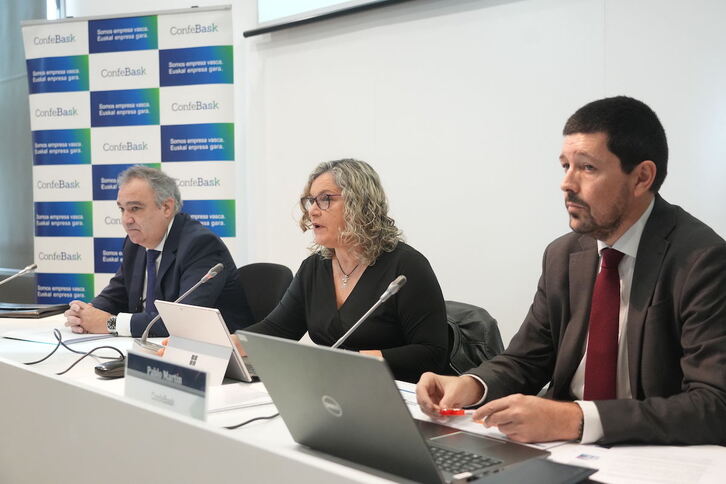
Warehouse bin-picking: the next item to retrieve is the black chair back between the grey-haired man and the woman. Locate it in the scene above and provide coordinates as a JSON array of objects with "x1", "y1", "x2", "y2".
[{"x1": 237, "y1": 262, "x2": 292, "y2": 322}]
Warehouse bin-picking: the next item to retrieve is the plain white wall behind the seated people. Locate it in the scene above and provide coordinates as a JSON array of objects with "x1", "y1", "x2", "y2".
[{"x1": 61, "y1": 0, "x2": 726, "y2": 342}]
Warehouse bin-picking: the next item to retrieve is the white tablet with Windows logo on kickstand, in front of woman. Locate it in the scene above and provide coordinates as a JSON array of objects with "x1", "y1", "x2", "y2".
[{"x1": 154, "y1": 300, "x2": 257, "y2": 382}]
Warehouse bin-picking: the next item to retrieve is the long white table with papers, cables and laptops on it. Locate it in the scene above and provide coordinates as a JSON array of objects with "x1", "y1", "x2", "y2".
[{"x1": 0, "y1": 315, "x2": 726, "y2": 484}]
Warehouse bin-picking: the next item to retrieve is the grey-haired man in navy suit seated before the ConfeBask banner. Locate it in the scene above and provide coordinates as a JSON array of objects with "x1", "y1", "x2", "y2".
[{"x1": 65, "y1": 166, "x2": 254, "y2": 336}]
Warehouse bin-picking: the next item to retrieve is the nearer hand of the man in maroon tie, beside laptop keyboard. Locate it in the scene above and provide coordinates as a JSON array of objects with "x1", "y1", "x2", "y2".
[{"x1": 473, "y1": 394, "x2": 582, "y2": 442}]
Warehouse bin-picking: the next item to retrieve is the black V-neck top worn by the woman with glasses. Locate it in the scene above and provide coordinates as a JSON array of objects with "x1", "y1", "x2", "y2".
[{"x1": 246, "y1": 242, "x2": 448, "y2": 382}]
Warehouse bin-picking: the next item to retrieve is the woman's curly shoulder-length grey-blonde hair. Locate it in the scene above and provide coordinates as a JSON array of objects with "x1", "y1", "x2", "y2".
[{"x1": 300, "y1": 159, "x2": 403, "y2": 265}]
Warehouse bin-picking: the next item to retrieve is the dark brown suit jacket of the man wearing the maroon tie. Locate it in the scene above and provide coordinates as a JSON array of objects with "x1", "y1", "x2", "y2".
[{"x1": 470, "y1": 196, "x2": 726, "y2": 444}]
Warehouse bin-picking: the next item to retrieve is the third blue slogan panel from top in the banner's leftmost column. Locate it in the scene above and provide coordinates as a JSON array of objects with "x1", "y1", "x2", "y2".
[{"x1": 35, "y1": 201, "x2": 93, "y2": 237}]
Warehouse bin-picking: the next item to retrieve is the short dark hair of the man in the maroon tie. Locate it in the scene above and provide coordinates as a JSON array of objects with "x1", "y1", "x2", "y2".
[{"x1": 562, "y1": 96, "x2": 668, "y2": 193}]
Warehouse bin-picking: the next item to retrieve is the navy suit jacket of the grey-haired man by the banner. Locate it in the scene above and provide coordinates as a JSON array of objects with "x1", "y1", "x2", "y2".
[{"x1": 92, "y1": 213, "x2": 254, "y2": 336}]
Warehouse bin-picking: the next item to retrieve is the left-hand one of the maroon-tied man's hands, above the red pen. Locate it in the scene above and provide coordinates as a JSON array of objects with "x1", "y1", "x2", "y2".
[{"x1": 416, "y1": 372, "x2": 484, "y2": 417}]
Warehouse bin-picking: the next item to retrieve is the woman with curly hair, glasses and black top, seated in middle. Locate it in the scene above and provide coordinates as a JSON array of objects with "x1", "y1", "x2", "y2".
[{"x1": 246, "y1": 159, "x2": 448, "y2": 382}]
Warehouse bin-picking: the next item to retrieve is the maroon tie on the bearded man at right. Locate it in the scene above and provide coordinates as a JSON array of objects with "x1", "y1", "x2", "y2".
[{"x1": 584, "y1": 248, "x2": 624, "y2": 400}]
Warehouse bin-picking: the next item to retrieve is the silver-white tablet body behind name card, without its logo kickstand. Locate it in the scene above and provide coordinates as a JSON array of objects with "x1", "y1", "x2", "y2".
[{"x1": 154, "y1": 300, "x2": 257, "y2": 382}]
